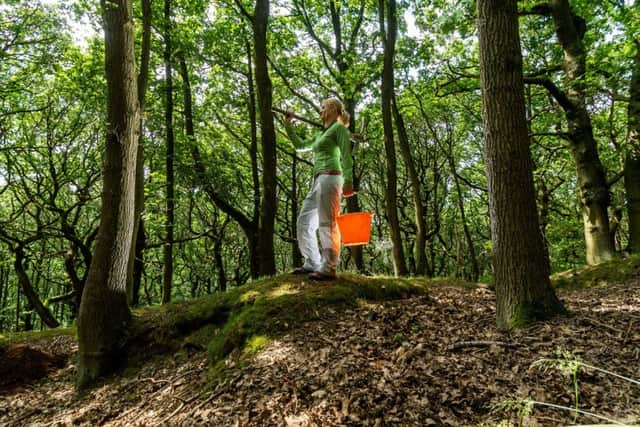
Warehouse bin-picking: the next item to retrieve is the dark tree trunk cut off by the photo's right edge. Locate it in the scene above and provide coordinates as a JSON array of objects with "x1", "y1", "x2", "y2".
[{"x1": 624, "y1": 39, "x2": 640, "y2": 253}]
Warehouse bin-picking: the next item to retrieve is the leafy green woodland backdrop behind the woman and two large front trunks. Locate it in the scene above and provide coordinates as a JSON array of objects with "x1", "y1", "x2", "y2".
[{"x1": 0, "y1": 0, "x2": 640, "y2": 331}]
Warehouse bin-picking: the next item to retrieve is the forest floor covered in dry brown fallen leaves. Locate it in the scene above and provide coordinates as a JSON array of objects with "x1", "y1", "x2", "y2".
[{"x1": 0, "y1": 276, "x2": 640, "y2": 426}]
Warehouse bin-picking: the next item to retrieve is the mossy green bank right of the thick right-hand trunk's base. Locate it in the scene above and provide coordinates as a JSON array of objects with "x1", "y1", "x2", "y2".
[{"x1": 551, "y1": 255, "x2": 640, "y2": 290}]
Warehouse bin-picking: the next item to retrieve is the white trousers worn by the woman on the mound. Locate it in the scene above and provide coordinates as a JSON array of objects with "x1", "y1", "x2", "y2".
[{"x1": 296, "y1": 175, "x2": 344, "y2": 275}]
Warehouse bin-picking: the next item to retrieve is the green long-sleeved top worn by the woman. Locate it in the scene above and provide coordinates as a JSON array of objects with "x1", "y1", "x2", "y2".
[{"x1": 285, "y1": 121, "x2": 353, "y2": 183}]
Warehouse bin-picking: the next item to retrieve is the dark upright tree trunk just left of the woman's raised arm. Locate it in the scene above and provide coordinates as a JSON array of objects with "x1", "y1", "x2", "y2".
[{"x1": 253, "y1": 0, "x2": 278, "y2": 276}]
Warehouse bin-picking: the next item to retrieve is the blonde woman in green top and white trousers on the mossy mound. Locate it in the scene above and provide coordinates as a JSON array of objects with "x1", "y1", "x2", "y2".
[{"x1": 284, "y1": 98, "x2": 353, "y2": 280}]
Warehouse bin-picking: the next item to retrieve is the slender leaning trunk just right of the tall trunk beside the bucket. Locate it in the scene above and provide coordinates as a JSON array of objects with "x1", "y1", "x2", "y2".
[{"x1": 392, "y1": 96, "x2": 429, "y2": 276}]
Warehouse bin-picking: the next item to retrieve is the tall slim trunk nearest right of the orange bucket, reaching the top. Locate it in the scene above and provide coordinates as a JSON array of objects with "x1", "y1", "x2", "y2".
[{"x1": 379, "y1": 0, "x2": 408, "y2": 276}]
